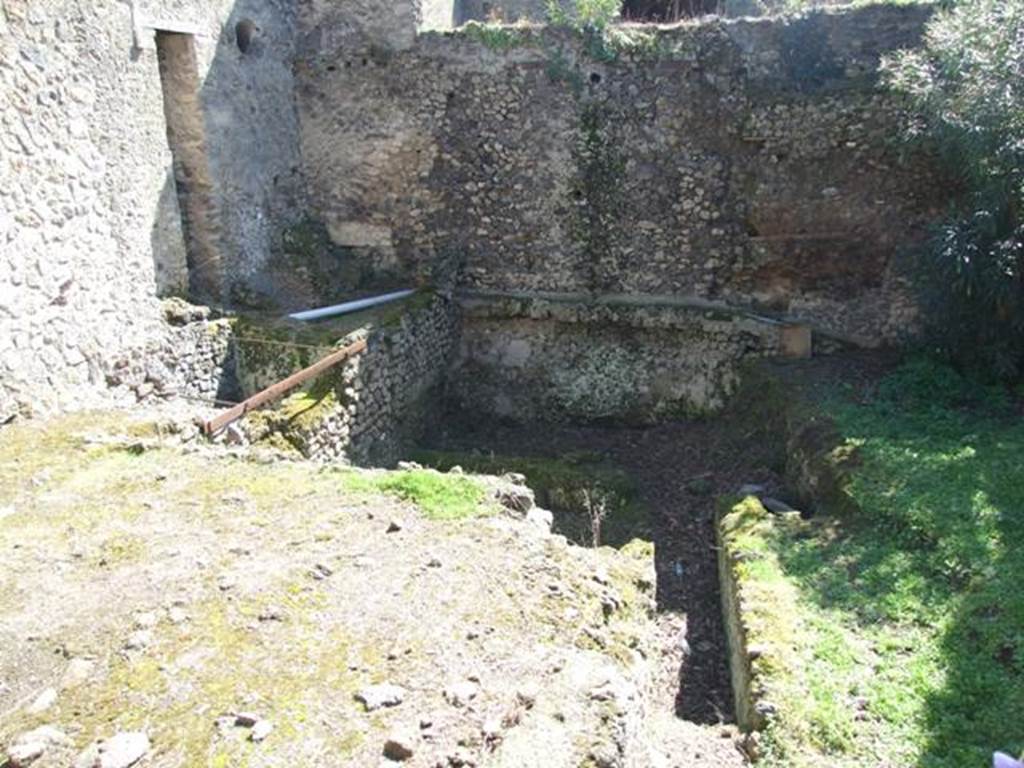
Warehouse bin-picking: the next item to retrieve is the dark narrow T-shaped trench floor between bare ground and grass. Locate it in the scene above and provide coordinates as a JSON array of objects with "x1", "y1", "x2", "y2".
[{"x1": 426, "y1": 419, "x2": 781, "y2": 725}]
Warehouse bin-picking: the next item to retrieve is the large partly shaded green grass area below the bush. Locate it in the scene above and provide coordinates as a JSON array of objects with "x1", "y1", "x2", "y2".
[{"x1": 753, "y1": 362, "x2": 1024, "y2": 768}]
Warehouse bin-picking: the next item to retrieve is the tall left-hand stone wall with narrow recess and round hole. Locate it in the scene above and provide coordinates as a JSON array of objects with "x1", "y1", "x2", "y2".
[{"x1": 0, "y1": 0, "x2": 301, "y2": 421}]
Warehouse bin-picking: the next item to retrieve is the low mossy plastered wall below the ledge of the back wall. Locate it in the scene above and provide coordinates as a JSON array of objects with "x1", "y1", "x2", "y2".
[{"x1": 450, "y1": 290, "x2": 783, "y2": 422}]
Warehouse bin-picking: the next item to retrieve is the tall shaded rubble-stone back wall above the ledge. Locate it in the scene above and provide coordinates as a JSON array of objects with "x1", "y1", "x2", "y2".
[{"x1": 297, "y1": 6, "x2": 942, "y2": 345}]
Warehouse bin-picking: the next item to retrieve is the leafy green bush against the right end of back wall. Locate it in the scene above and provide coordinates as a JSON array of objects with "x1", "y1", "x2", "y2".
[{"x1": 887, "y1": 0, "x2": 1024, "y2": 378}]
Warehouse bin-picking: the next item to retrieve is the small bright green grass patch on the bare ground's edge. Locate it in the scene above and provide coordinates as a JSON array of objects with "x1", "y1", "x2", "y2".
[{"x1": 347, "y1": 469, "x2": 485, "y2": 520}]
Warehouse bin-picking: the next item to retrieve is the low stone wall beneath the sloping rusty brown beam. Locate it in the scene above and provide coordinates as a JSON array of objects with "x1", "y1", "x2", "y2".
[{"x1": 239, "y1": 296, "x2": 459, "y2": 465}]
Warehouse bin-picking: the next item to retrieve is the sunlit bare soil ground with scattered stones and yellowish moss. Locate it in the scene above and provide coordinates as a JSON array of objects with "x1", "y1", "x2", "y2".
[{"x1": 0, "y1": 405, "x2": 742, "y2": 768}]
